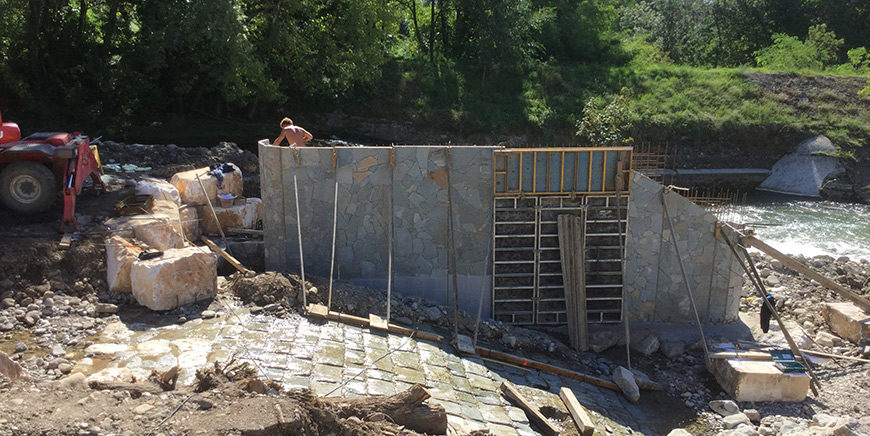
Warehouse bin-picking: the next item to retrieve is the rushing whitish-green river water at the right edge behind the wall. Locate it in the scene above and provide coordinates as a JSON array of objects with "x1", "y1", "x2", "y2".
[{"x1": 723, "y1": 192, "x2": 870, "y2": 260}]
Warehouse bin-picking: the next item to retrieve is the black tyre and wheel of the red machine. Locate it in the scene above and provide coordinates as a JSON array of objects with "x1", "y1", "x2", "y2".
[{"x1": 0, "y1": 161, "x2": 57, "y2": 214}]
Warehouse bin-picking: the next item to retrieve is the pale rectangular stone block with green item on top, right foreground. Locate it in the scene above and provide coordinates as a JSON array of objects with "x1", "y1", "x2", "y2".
[{"x1": 708, "y1": 359, "x2": 810, "y2": 402}]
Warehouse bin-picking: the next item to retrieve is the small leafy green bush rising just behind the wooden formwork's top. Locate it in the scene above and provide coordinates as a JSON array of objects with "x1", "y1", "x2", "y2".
[{"x1": 577, "y1": 88, "x2": 634, "y2": 147}]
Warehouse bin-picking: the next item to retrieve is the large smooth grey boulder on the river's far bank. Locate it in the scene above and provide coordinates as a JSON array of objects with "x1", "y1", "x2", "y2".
[{"x1": 758, "y1": 135, "x2": 842, "y2": 197}]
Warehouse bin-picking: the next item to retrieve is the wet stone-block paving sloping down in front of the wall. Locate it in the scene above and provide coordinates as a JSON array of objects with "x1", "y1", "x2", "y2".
[{"x1": 76, "y1": 306, "x2": 650, "y2": 435}]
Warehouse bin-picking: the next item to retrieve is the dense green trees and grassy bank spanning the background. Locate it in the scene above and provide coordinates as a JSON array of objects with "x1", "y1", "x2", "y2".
[{"x1": 0, "y1": 0, "x2": 870, "y2": 152}]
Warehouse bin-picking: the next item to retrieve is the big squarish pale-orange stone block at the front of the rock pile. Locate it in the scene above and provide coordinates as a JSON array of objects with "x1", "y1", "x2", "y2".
[{"x1": 130, "y1": 247, "x2": 217, "y2": 310}]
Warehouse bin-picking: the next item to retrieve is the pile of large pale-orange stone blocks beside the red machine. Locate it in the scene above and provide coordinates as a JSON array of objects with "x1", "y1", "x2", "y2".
[{"x1": 106, "y1": 164, "x2": 262, "y2": 310}]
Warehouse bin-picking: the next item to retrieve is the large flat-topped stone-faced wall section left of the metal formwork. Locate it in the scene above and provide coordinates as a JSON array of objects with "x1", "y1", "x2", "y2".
[{"x1": 259, "y1": 142, "x2": 494, "y2": 316}]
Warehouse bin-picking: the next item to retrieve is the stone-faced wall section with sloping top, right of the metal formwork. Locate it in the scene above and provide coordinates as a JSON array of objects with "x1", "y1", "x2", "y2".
[{"x1": 624, "y1": 173, "x2": 743, "y2": 323}]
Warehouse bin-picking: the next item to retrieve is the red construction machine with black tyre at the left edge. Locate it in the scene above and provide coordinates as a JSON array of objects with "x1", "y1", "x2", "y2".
[{"x1": 0, "y1": 110, "x2": 106, "y2": 231}]
